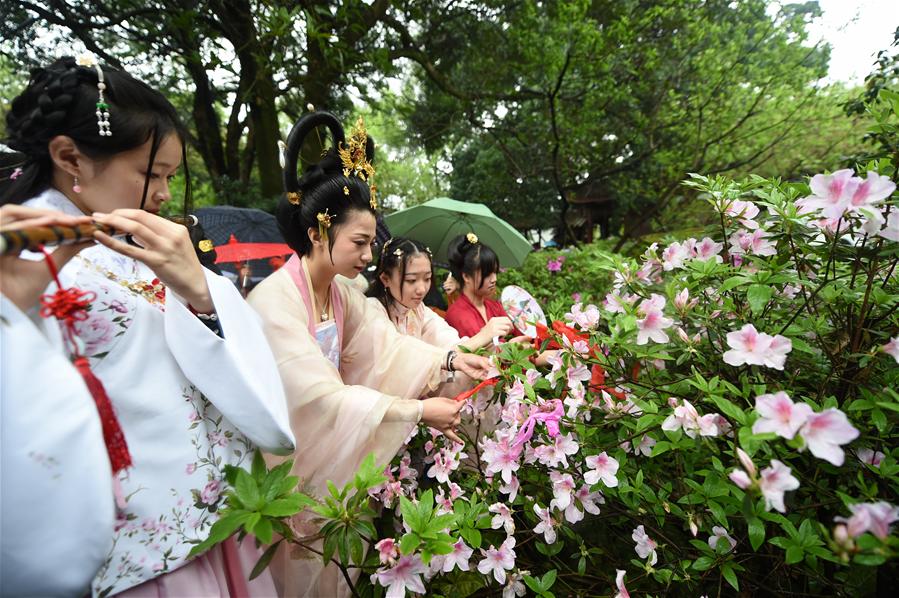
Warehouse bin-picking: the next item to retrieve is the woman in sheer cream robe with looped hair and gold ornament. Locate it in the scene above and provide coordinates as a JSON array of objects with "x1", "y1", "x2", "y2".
[{"x1": 249, "y1": 112, "x2": 489, "y2": 596}]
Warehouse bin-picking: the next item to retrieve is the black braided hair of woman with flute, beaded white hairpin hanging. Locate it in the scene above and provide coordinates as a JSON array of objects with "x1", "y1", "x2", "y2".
[{"x1": 0, "y1": 56, "x2": 190, "y2": 209}]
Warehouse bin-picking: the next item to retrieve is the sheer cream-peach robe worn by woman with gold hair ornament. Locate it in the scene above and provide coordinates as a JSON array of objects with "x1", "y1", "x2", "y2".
[{"x1": 248, "y1": 256, "x2": 446, "y2": 597}]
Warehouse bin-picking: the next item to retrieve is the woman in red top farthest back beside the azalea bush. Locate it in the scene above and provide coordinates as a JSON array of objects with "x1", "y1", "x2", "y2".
[{"x1": 446, "y1": 233, "x2": 520, "y2": 337}]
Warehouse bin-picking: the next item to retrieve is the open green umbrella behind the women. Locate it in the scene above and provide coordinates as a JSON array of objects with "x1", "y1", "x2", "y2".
[{"x1": 384, "y1": 197, "x2": 531, "y2": 268}]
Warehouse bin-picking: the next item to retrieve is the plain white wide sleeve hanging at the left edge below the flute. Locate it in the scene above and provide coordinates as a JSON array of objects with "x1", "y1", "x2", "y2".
[{"x1": 0, "y1": 297, "x2": 115, "y2": 596}]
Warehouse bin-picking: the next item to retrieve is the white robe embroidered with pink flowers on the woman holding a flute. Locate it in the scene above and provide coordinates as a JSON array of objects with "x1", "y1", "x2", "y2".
[{"x1": 25, "y1": 189, "x2": 294, "y2": 595}]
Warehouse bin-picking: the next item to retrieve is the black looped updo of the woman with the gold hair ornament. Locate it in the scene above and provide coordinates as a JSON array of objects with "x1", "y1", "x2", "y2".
[{"x1": 276, "y1": 112, "x2": 376, "y2": 264}]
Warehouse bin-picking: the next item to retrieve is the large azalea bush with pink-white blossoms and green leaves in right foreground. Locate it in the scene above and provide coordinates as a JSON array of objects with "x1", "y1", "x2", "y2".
[{"x1": 197, "y1": 94, "x2": 899, "y2": 598}]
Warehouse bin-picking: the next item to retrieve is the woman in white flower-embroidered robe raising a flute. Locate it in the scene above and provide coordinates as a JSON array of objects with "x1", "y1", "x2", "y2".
[{"x1": 0, "y1": 58, "x2": 294, "y2": 596}]
